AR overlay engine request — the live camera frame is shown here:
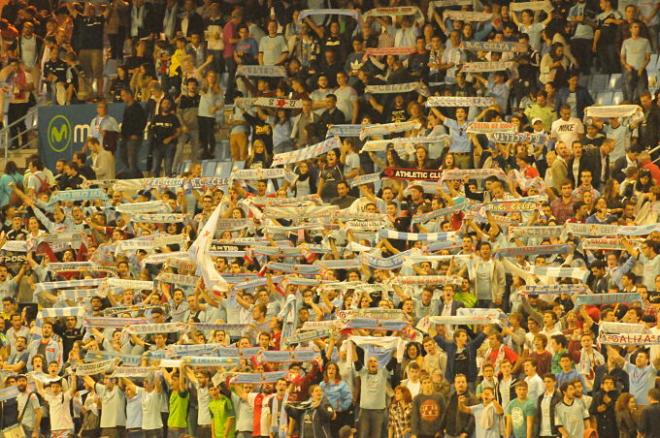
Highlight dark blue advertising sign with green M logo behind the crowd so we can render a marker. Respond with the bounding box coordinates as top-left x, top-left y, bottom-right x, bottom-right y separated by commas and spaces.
38, 103, 124, 169
